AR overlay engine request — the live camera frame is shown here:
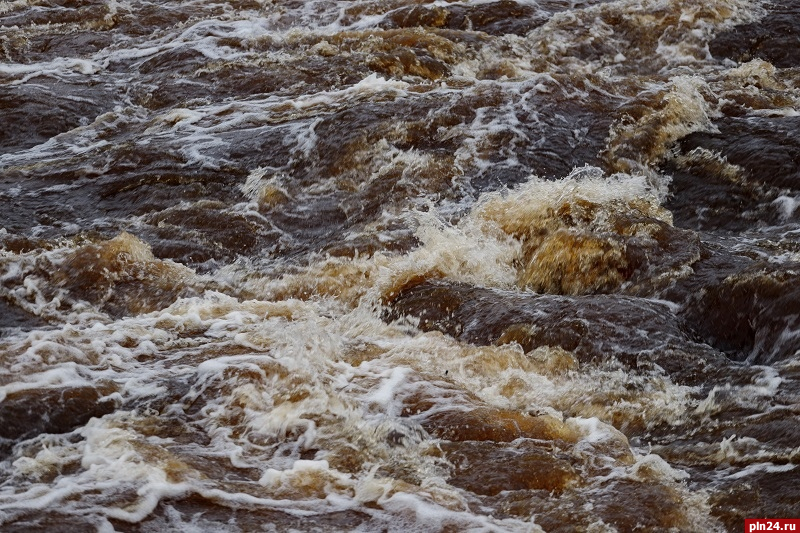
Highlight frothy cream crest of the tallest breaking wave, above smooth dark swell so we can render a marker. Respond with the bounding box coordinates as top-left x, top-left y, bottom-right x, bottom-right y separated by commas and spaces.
346, 167, 671, 301
